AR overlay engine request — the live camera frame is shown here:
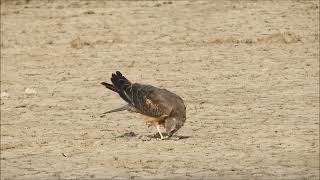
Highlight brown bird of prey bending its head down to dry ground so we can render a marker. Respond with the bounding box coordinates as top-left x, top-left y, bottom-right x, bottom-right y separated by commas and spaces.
101, 71, 186, 140
